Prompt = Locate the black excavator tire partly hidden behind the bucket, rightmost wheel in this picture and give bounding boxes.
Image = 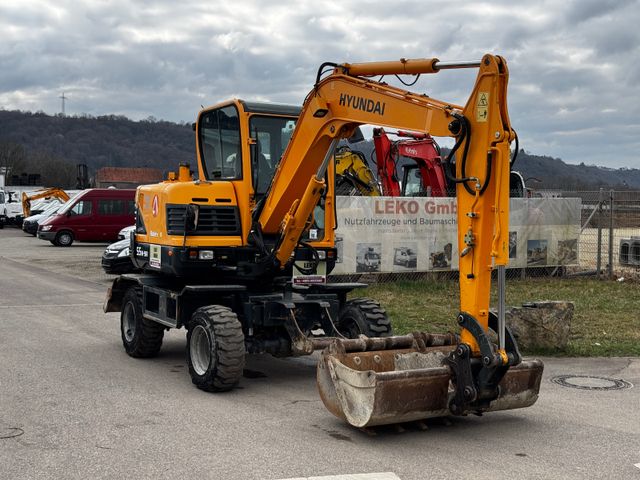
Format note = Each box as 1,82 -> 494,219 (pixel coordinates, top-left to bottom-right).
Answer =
337,298 -> 393,338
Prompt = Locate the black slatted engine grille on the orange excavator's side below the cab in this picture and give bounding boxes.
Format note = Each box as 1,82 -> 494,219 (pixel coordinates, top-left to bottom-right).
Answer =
167,204 -> 241,236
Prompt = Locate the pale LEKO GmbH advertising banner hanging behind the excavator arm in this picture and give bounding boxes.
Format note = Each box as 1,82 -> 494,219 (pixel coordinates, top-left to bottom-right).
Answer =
333,196 -> 581,274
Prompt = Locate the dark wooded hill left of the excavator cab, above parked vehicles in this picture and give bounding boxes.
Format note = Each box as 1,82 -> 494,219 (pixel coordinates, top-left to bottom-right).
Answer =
0,110 -> 195,188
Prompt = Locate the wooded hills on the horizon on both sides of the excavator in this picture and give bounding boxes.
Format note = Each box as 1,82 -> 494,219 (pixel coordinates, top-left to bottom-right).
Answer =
0,110 -> 640,190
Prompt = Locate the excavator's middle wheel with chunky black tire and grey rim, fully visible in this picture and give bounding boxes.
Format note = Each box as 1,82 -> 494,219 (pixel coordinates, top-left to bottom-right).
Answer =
187,305 -> 245,392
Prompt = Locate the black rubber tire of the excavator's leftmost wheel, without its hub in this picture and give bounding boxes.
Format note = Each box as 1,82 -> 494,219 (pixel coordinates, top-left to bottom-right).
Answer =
120,286 -> 165,358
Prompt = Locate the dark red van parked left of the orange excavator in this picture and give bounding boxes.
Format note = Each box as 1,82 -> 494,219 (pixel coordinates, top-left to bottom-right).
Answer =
38,188 -> 136,247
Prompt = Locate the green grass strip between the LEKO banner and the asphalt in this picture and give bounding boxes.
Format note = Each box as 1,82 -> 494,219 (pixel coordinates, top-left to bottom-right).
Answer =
353,278 -> 640,356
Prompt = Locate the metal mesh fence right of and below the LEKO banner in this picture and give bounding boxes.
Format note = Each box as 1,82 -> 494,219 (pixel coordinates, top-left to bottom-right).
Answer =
333,189 -> 640,283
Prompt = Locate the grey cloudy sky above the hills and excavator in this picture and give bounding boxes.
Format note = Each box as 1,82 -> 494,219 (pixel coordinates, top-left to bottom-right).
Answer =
0,0 -> 640,168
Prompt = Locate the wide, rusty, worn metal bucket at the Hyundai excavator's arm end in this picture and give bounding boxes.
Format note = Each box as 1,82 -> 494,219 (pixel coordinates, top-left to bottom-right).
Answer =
317,333 -> 543,428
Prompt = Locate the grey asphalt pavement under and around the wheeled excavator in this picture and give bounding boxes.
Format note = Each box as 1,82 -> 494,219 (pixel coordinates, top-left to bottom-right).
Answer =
0,228 -> 640,480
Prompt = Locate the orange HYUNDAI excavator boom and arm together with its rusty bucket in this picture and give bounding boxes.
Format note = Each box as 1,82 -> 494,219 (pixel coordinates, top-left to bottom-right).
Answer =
259,55 -> 543,426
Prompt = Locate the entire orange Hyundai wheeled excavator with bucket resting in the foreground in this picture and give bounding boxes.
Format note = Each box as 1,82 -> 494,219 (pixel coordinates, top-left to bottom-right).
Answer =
105,55 -> 543,427
